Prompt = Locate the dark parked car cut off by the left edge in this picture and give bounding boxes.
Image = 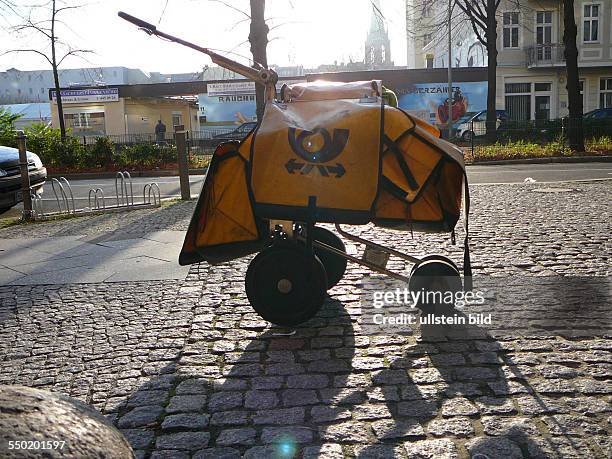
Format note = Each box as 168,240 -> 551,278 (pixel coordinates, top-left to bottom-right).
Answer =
0,146 -> 47,214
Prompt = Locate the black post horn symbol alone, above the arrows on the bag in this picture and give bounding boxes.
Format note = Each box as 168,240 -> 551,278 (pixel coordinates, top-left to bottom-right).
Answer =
289,128 -> 349,164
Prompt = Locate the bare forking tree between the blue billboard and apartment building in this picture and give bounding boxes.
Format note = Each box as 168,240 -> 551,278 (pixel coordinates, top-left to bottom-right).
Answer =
456,0 -> 501,141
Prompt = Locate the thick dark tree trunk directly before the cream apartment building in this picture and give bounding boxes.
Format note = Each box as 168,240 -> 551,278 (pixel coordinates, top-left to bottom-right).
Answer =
563,0 -> 584,151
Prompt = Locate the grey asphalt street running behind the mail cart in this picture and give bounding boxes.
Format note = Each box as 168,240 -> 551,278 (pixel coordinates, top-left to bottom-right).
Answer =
3,162 -> 612,217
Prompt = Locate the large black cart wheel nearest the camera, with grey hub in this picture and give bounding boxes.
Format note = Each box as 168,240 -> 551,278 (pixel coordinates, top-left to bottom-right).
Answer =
245,245 -> 327,326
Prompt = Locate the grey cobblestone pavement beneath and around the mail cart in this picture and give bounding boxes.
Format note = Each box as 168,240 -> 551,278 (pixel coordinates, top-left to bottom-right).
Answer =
0,182 -> 612,459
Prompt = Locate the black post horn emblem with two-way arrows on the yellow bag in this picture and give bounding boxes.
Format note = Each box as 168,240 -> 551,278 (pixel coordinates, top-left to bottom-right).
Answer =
285,128 -> 349,178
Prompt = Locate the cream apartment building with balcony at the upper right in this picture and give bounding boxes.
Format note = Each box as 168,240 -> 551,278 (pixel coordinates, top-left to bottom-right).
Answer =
497,0 -> 612,120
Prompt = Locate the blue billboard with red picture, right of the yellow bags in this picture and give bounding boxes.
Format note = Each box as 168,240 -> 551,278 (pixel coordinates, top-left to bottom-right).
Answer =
397,81 -> 487,126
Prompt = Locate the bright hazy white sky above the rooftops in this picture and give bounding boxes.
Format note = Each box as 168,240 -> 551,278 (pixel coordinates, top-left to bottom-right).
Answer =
0,0 -> 406,73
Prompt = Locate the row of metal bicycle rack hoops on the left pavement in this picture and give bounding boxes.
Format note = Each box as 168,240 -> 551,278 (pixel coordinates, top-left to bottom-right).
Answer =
31,171 -> 161,220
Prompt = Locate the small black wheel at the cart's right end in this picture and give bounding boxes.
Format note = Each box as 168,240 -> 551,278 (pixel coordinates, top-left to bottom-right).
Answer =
409,255 -> 463,313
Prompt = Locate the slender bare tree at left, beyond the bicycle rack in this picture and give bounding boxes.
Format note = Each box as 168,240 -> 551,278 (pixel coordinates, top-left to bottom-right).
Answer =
3,0 -> 91,140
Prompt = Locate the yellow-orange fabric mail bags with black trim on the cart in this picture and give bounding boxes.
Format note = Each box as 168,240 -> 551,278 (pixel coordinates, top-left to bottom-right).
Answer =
179,82 -> 465,264
